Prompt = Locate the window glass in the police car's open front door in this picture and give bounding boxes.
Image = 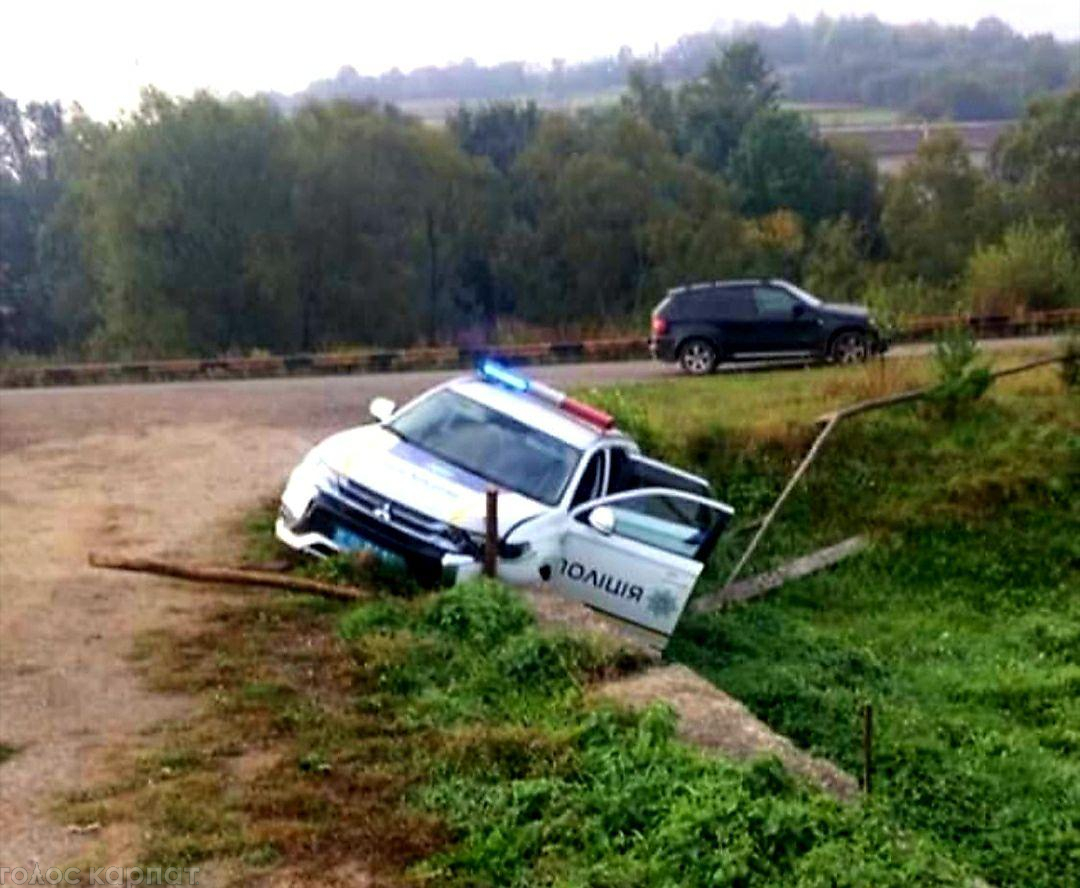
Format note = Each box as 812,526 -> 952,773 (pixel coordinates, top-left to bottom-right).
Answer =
596,493 -> 718,559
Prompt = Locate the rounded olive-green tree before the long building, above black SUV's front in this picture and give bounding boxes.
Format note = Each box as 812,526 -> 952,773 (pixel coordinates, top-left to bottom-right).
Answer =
881,132 -> 1003,282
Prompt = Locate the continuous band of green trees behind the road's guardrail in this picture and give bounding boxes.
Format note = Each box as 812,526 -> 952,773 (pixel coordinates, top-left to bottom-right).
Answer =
0,43 -> 1080,356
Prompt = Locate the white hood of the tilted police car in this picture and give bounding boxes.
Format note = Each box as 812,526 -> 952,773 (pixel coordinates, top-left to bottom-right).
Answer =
316,425 -> 551,535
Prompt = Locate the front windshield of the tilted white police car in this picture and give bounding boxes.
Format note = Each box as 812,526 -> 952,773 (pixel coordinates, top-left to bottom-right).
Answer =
387,389 -> 581,506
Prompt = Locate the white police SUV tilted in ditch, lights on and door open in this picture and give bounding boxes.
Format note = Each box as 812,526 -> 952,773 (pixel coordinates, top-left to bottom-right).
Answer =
275,361 -> 732,637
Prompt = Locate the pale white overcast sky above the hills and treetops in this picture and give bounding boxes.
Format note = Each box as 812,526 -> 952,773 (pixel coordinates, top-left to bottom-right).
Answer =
6,0 -> 1080,118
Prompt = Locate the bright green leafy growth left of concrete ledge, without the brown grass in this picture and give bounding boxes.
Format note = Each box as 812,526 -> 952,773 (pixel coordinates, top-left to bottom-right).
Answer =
341,584 -> 964,886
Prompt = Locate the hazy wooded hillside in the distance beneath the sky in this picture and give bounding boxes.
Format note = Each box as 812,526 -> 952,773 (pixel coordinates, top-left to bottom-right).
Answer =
270,16 -> 1080,120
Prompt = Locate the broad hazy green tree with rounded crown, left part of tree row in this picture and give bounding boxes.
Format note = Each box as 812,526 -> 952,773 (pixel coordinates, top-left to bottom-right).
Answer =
76,90 -> 287,354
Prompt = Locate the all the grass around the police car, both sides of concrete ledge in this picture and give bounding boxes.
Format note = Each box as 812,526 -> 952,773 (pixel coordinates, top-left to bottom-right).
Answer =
62,343 -> 1078,886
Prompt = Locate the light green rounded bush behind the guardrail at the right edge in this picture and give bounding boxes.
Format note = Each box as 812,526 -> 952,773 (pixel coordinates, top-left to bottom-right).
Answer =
967,219 -> 1080,315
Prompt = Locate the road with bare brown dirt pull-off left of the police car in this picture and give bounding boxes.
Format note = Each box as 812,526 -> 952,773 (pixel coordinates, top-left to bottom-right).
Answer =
0,332 -> 1062,869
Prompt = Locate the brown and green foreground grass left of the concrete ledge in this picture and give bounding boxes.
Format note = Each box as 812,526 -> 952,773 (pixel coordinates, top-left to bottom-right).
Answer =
78,561 -> 971,888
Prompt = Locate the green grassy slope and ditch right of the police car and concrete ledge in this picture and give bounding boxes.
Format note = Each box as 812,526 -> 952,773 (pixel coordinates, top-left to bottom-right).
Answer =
587,352 -> 1080,886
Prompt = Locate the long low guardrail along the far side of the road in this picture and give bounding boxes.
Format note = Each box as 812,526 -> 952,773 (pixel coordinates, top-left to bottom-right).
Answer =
0,309 -> 1080,388
